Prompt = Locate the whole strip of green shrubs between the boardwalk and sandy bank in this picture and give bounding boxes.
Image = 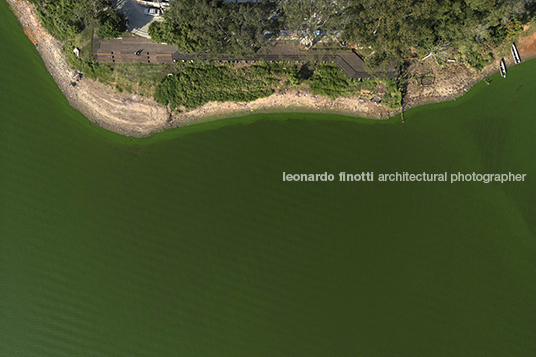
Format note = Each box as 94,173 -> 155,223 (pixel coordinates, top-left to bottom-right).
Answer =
154,61 -> 401,109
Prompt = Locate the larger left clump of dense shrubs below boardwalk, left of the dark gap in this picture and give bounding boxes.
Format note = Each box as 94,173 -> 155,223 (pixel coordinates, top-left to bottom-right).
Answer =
155,62 -> 297,109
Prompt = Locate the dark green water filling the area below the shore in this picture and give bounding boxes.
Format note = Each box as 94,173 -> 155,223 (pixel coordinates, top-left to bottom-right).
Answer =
0,0 -> 536,357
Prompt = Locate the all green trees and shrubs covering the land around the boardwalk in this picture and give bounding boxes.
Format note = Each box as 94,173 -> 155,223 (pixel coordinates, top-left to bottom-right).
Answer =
25,0 -> 536,108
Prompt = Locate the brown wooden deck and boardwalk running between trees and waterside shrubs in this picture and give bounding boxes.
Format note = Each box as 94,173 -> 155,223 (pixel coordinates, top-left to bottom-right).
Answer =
93,37 -> 394,78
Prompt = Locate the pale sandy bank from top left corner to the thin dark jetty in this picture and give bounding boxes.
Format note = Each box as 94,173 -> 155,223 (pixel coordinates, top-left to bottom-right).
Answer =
7,0 -> 396,137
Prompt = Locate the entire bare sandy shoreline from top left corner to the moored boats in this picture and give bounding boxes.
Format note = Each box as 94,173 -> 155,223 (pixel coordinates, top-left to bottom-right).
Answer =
7,0 -> 536,138
